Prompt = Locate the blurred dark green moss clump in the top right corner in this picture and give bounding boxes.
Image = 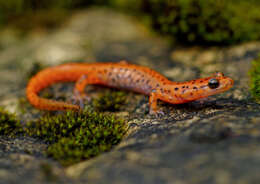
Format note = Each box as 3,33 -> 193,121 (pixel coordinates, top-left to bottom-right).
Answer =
138,0 -> 260,44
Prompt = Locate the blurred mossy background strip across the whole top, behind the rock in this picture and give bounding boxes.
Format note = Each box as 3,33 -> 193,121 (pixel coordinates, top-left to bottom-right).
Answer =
0,0 -> 260,45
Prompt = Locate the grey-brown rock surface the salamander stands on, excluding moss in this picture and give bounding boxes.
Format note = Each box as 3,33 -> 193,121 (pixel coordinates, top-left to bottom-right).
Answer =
0,9 -> 260,184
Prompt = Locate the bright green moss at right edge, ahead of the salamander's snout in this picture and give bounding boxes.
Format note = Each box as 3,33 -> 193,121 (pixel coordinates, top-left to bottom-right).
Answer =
249,56 -> 260,103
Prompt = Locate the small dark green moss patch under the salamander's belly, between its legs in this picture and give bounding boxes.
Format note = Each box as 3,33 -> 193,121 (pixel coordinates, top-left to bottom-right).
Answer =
92,91 -> 127,112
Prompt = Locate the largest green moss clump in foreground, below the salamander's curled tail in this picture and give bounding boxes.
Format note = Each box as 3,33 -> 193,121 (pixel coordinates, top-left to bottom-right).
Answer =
25,111 -> 126,166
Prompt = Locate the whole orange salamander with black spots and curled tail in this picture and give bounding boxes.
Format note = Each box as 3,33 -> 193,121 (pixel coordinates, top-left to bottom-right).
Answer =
26,61 -> 234,114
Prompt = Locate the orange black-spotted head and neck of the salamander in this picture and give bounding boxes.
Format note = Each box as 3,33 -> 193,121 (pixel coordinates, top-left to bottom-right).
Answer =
162,72 -> 234,103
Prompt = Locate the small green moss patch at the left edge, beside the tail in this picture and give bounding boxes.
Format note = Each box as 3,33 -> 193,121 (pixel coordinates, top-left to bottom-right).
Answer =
0,107 -> 23,137
